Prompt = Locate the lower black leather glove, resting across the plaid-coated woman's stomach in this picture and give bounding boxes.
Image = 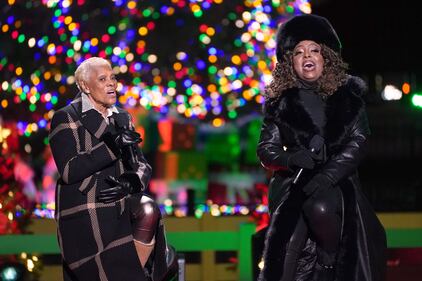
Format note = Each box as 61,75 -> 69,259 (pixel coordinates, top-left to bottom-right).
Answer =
97,172 -> 144,204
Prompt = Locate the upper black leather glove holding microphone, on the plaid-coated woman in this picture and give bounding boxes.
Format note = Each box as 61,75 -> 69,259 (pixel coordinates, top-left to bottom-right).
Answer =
102,129 -> 142,157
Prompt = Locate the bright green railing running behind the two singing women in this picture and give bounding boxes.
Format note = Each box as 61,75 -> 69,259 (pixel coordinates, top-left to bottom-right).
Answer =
0,215 -> 422,280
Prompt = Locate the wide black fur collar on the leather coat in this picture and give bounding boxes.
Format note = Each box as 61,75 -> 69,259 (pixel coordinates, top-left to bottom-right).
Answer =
264,76 -> 366,148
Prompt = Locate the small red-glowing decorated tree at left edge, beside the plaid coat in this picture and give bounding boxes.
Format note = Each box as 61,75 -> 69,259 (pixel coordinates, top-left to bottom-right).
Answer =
0,118 -> 40,281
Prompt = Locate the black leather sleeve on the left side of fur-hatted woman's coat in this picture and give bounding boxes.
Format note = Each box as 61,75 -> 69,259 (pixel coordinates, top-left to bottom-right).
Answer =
257,116 -> 291,170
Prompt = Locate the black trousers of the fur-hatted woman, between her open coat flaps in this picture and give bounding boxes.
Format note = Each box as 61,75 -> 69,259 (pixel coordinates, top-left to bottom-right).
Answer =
282,188 -> 342,281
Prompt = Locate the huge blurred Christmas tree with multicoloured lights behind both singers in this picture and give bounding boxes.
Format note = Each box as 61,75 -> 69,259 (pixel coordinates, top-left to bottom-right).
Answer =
0,0 -> 311,136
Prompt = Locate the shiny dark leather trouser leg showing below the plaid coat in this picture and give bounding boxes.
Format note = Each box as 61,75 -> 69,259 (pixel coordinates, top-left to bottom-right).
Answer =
129,195 -> 160,244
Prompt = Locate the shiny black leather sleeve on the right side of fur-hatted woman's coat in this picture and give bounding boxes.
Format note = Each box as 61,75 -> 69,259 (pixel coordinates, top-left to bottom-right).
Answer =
320,108 -> 370,185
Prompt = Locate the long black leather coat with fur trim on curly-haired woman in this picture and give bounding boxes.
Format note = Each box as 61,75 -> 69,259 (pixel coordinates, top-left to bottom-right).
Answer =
257,77 -> 386,281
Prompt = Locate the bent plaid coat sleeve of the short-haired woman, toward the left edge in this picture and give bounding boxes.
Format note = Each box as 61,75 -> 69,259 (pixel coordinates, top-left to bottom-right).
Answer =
49,110 -> 117,184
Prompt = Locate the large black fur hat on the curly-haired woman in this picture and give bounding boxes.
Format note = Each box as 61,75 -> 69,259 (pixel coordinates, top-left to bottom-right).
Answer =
276,14 -> 341,61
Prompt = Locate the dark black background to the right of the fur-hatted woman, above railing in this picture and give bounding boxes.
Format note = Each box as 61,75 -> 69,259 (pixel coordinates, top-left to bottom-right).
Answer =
310,0 -> 422,211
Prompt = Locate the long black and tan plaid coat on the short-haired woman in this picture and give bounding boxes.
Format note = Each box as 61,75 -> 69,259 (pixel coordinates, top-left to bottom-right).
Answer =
49,94 -> 167,281
